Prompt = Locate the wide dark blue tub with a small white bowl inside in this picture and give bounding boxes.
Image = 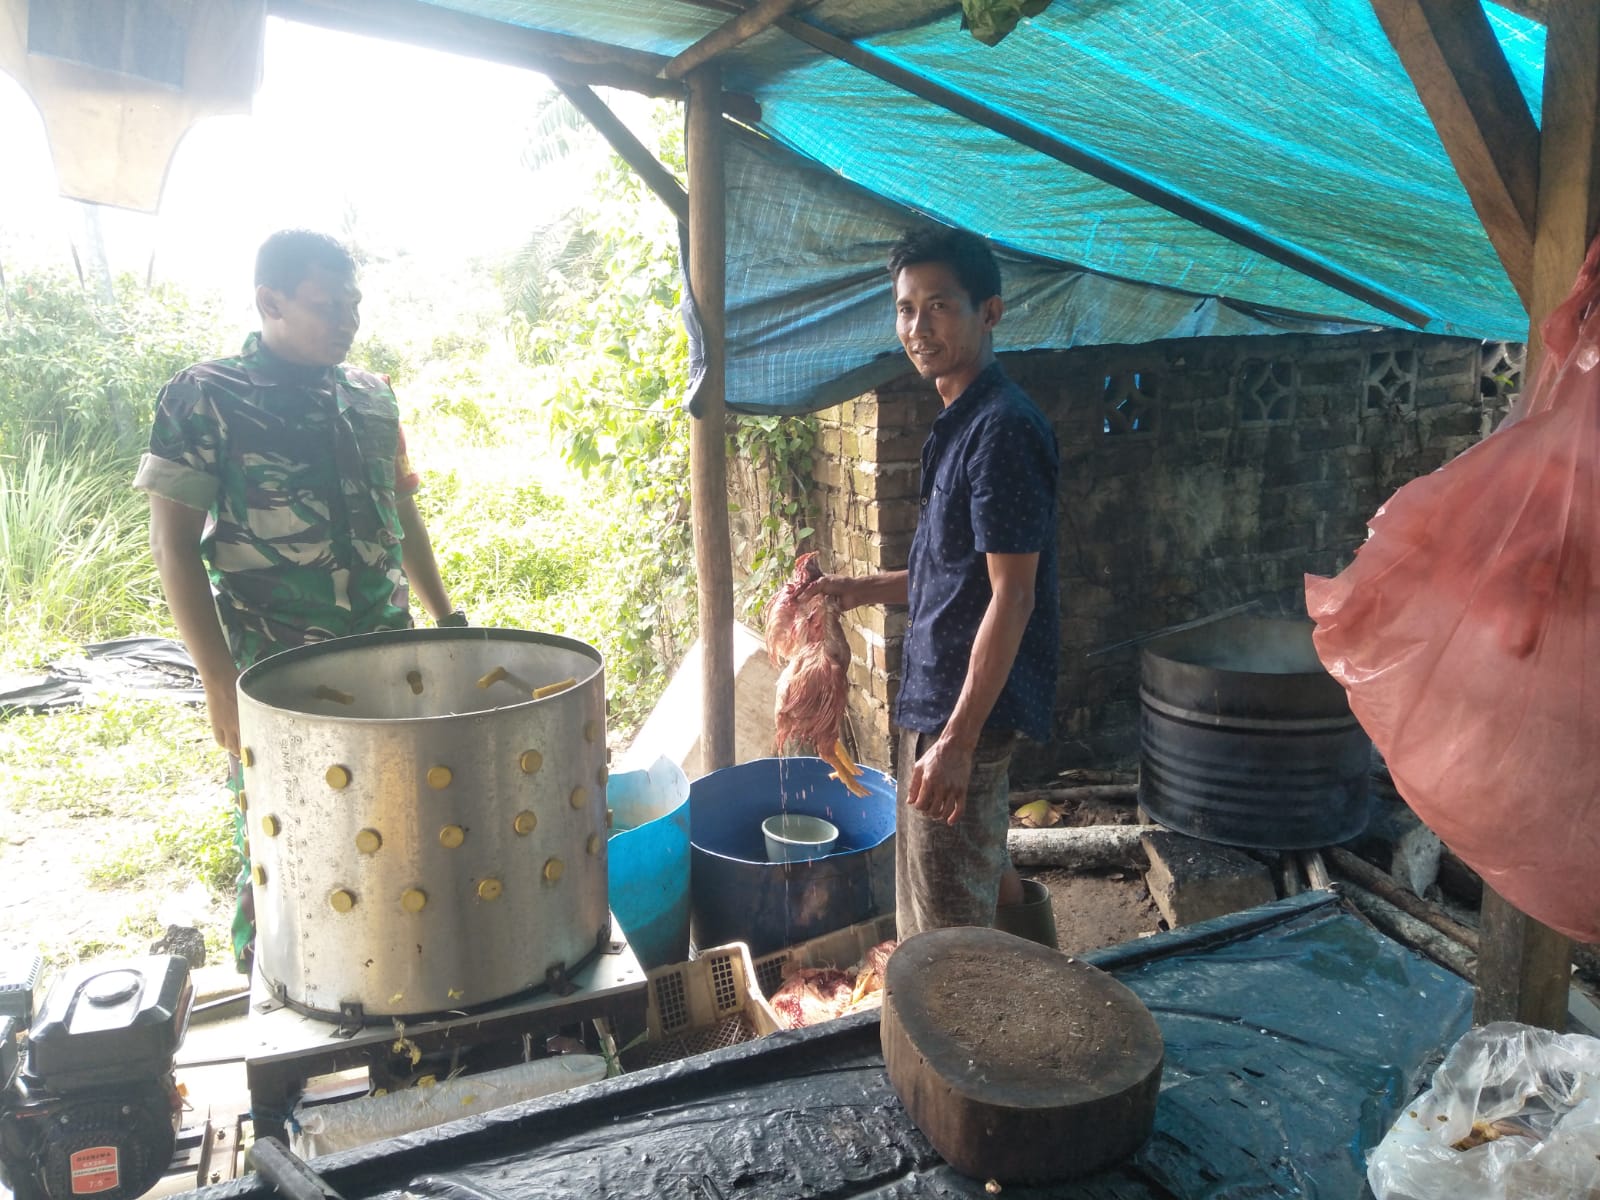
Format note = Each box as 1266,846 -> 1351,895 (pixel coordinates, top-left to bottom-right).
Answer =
690,758 -> 894,955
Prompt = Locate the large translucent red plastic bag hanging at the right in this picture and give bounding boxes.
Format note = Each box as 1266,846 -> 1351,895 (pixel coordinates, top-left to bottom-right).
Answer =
1306,240 -> 1600,941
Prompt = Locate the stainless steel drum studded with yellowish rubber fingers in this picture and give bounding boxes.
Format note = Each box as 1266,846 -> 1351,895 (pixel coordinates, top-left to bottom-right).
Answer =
240,629 -> 610,1018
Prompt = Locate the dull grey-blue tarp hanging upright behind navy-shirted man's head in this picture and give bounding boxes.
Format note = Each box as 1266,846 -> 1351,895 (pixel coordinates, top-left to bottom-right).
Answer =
707,131 -> 1371,413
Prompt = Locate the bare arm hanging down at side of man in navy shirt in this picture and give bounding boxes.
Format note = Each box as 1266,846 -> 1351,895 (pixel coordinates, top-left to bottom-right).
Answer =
907,554 -> 1038,826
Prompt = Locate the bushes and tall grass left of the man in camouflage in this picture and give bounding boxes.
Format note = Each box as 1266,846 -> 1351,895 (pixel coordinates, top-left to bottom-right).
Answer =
0,274 -> 218,678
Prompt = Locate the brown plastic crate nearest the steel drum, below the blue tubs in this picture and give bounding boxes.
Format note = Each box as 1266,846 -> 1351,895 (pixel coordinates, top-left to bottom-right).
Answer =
622,942 -> 778,1070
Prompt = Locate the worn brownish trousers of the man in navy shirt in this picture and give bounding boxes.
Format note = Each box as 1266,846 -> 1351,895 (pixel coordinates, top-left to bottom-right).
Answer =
894,730 -> 1016,939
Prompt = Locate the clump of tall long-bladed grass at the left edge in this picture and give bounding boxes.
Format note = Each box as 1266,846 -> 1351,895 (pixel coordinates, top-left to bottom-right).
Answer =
0,437 -> 166,662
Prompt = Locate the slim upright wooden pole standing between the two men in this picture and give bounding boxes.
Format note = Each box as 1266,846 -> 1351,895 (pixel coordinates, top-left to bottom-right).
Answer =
686,66 -> 734,771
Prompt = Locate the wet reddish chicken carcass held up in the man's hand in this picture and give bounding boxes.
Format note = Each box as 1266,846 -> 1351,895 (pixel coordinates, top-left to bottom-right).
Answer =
766,552 -> 867,795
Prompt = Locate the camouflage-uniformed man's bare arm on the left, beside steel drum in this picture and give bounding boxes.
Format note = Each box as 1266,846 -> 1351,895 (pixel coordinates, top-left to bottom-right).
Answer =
150,493 -> 238,755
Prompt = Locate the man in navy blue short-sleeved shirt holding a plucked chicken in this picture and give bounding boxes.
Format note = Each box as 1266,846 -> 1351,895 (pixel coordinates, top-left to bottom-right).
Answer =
813,227 -> 1059,938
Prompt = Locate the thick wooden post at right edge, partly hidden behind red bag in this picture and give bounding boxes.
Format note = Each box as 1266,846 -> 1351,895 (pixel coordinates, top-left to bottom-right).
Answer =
1472,0 -> 1600,1030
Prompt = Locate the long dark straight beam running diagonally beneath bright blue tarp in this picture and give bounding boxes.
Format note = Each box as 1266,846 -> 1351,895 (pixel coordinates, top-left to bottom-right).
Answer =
768,12 -> 1433,328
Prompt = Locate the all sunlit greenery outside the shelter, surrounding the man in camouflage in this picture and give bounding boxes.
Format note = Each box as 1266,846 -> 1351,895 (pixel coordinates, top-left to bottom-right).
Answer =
0,101 -> 816,962
